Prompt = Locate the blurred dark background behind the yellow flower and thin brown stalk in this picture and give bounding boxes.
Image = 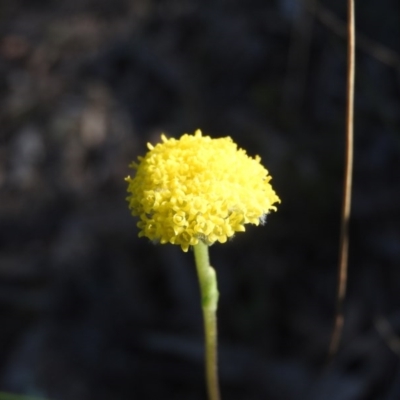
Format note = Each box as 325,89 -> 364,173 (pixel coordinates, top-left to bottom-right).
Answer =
0,0 -> 400,400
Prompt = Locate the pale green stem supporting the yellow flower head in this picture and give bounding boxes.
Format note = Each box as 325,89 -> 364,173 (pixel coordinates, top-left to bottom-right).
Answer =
194,241 -> 220,400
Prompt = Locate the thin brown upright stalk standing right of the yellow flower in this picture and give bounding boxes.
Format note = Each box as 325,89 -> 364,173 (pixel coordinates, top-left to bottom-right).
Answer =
328,0 -> 355,359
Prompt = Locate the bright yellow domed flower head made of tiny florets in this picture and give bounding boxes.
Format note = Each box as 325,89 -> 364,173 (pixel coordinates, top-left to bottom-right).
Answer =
126,130 -> 280,251
